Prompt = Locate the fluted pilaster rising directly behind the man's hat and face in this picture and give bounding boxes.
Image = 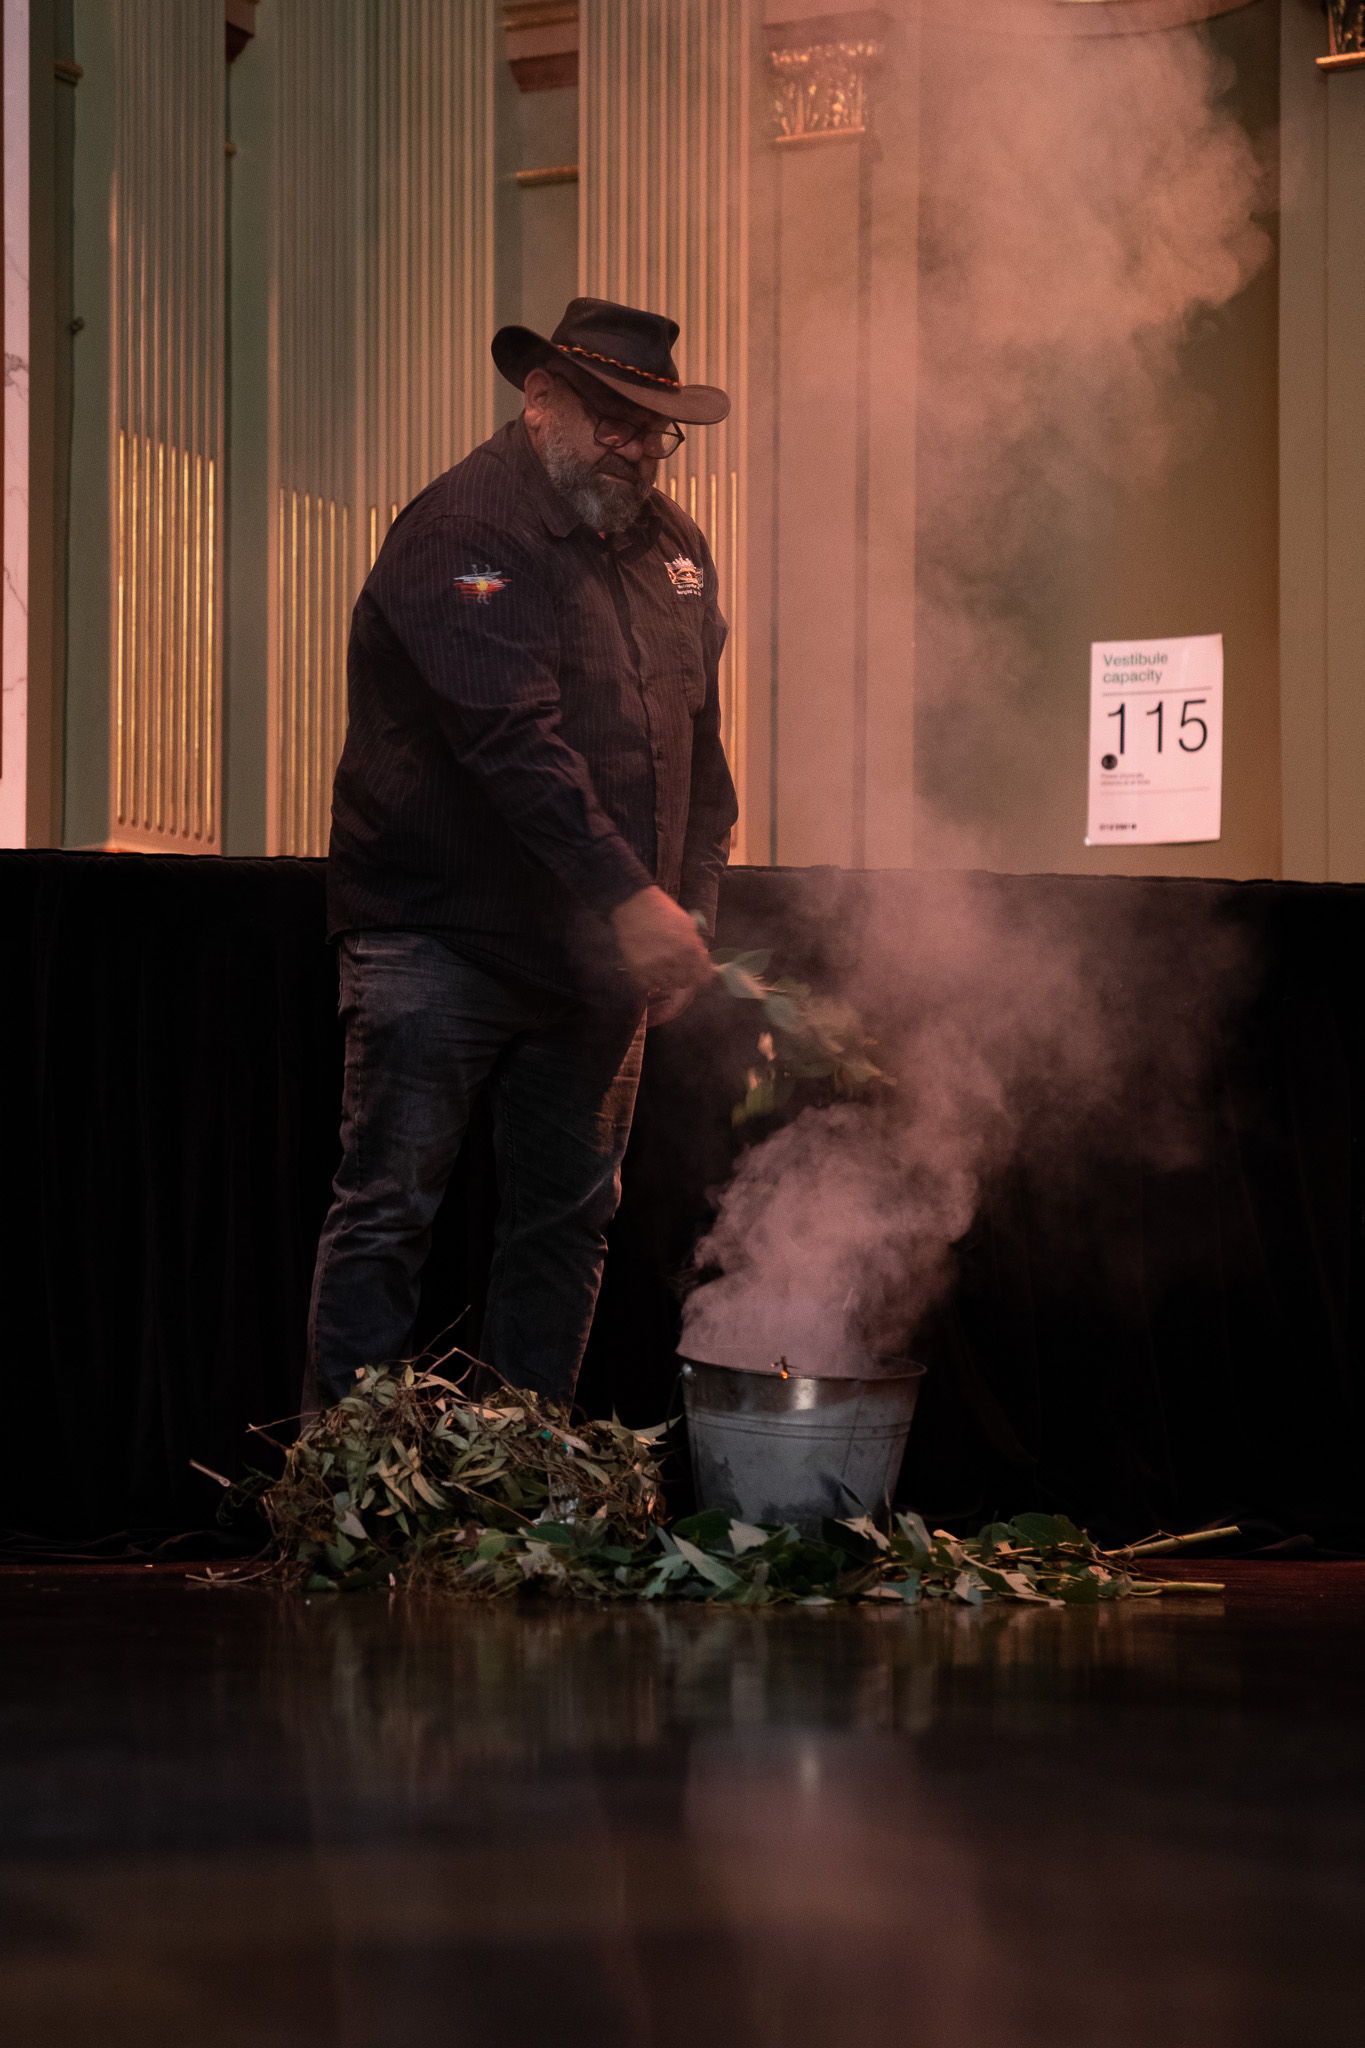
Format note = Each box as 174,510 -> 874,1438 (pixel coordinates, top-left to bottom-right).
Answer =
579,0 -> 753,860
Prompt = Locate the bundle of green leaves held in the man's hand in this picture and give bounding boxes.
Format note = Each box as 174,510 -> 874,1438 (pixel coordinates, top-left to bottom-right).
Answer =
712,950 -> 894,1124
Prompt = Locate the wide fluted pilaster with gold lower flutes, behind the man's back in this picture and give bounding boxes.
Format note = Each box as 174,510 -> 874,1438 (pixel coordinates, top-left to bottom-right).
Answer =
270,0 -> 501,854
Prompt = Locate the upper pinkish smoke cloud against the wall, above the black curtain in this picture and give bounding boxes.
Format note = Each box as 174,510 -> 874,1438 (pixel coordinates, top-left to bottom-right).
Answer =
917,8 -> 1271,862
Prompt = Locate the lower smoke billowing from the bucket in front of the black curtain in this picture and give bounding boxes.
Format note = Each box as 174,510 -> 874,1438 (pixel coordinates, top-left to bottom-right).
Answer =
684,874 -> 1250,1372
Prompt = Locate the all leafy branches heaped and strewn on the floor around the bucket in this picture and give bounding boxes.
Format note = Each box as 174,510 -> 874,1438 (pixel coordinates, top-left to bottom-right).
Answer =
211,1360 -> 1222,1606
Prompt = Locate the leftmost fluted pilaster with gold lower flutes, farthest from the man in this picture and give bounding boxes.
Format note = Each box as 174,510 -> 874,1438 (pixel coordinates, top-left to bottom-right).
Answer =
111,0 -> 225,852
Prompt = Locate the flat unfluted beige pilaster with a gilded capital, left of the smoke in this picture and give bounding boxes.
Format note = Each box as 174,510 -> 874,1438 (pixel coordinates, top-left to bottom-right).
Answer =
753,0 -> 919,868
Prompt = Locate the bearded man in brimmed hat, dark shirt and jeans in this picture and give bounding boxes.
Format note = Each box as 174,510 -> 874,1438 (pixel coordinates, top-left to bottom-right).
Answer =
305,299 -> 737,1403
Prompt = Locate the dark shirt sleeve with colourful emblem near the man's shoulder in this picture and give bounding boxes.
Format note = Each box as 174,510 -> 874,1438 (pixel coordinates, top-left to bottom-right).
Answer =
375,518 -> 653,915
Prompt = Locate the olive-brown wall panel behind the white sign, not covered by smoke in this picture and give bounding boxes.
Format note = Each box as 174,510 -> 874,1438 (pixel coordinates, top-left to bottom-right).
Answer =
919,0 -> 1281,877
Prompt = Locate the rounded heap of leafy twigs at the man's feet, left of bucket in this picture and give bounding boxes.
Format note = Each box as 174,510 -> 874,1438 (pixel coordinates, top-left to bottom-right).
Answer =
254,1360 -> 663,1591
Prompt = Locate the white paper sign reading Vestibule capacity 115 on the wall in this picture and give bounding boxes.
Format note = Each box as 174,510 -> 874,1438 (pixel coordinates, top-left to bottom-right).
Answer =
1085,633 -> 1224,846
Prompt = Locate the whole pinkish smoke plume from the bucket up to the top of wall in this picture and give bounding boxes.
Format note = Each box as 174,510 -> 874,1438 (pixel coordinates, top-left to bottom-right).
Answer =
684,8 -> 1269,1372
